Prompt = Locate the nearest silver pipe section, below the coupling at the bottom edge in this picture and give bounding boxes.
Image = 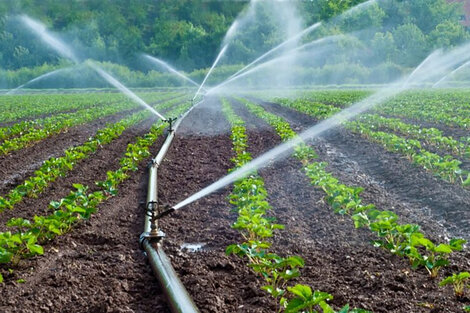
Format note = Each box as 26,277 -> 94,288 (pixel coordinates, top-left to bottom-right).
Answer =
143,240 -> 199,313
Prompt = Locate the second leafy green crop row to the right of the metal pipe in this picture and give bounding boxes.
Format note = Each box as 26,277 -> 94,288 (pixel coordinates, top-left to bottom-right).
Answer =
240,99 -> 466,298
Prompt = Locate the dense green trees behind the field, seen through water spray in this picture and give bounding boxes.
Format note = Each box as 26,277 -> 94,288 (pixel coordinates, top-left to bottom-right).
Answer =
0,0 -> 470,88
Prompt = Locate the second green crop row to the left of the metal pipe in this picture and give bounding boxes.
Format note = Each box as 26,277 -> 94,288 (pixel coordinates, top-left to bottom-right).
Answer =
0,96 -> 189,212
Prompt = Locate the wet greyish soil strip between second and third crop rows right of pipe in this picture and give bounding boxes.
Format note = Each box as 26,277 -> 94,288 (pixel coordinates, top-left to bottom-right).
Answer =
255,98 -> 470,239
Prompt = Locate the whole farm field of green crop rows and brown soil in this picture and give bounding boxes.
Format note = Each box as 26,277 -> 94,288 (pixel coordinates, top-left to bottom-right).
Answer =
0,89 -> 470,312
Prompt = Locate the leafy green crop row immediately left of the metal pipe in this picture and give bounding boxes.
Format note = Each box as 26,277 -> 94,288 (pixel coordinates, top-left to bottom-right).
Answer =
0,100 -> 189,280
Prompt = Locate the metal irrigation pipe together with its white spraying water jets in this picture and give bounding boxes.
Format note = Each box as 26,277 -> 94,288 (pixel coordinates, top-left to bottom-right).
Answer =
10,0 -> 470,313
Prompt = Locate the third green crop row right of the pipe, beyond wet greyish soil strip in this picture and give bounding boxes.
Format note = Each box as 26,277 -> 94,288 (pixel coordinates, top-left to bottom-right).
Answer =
277,99 -> 470,186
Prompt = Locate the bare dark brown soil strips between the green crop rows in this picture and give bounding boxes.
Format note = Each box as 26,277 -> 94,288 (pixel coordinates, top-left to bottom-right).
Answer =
0,95 -> 470,313
